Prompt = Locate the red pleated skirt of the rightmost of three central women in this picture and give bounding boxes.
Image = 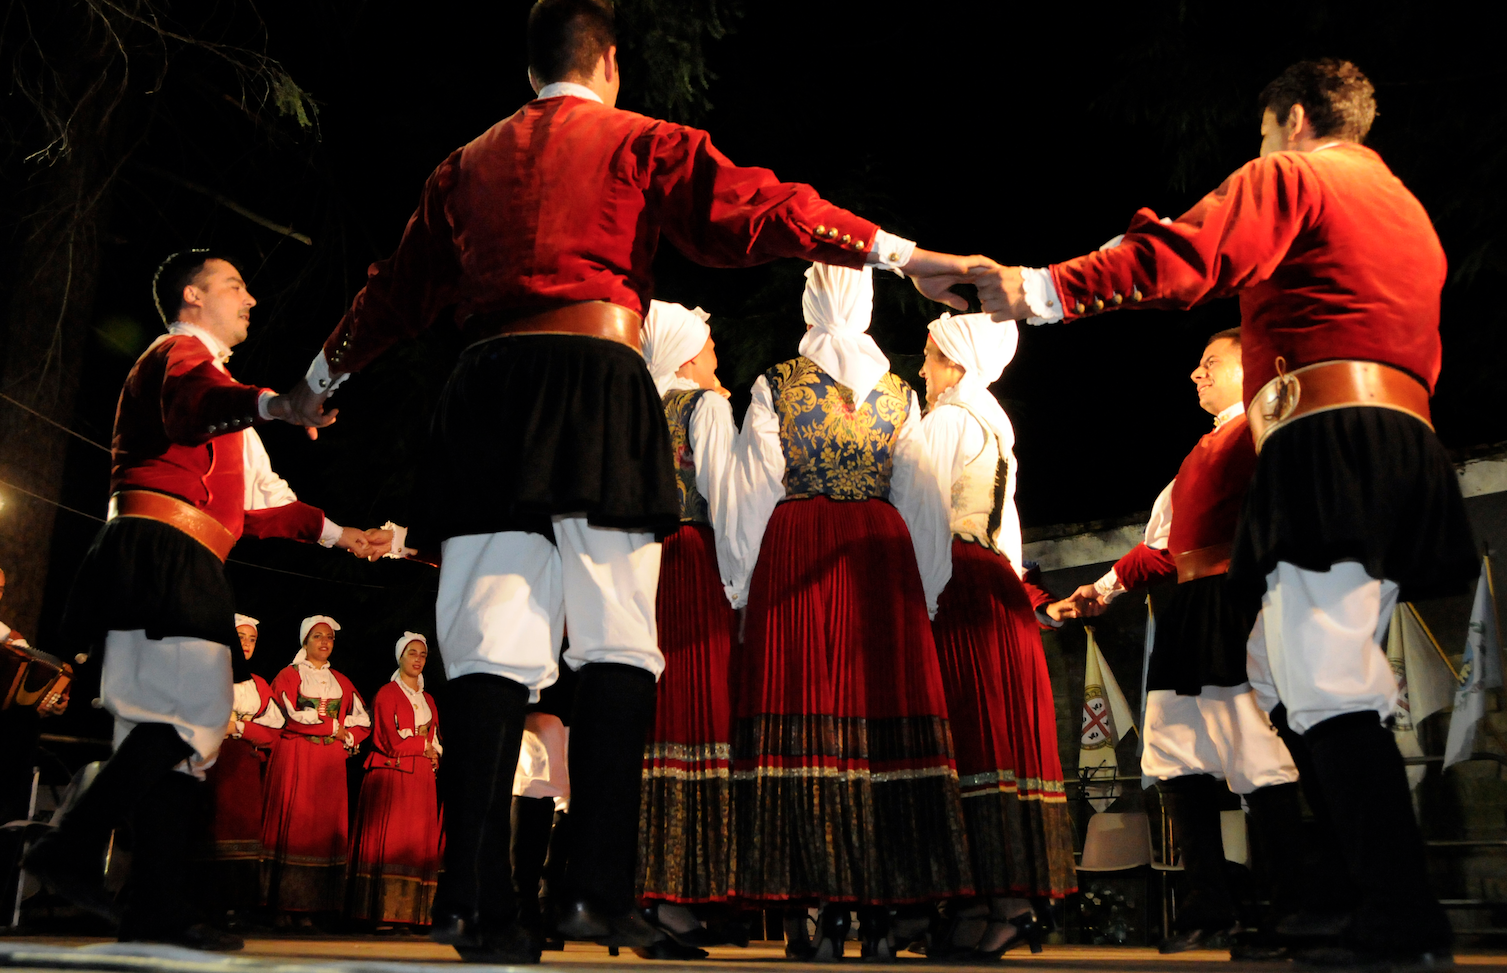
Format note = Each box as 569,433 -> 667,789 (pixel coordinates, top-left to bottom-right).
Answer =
933,538 -> 1078,898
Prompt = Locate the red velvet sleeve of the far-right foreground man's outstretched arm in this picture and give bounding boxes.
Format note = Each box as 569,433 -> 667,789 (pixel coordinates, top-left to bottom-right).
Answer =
1050,152 -> 1316,319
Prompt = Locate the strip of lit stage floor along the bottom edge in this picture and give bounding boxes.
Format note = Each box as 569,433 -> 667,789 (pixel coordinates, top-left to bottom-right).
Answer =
0,935 -> 1507,973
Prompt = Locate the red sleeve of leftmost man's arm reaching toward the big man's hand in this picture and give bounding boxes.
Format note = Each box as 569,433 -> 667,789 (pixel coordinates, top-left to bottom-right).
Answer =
161,336 -> 274,446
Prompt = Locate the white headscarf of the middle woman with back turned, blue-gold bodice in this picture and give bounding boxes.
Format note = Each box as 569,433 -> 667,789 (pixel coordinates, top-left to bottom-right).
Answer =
800,264 -> 889,405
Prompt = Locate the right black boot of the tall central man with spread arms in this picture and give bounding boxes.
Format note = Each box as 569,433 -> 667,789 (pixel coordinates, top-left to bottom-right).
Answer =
559,663 -> 659,946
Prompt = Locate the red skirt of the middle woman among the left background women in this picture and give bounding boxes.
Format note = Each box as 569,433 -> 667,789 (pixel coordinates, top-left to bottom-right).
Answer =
262,735 -> 350,913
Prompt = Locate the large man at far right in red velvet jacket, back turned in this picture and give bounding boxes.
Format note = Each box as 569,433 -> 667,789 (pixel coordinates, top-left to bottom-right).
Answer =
971,60 -> 1477,967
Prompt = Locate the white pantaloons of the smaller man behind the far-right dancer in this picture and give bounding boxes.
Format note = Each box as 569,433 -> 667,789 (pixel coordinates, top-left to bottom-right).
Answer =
1141,682 -> 1298,794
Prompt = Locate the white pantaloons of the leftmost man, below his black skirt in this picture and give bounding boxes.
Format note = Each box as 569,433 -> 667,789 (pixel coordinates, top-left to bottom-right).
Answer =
99,628 -> 240,780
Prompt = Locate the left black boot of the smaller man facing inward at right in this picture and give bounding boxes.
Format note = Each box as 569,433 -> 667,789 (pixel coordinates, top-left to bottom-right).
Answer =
1156,774 -> 1236,953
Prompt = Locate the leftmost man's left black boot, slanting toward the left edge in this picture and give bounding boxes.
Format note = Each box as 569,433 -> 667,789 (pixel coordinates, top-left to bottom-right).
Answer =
26,723 -> 193,922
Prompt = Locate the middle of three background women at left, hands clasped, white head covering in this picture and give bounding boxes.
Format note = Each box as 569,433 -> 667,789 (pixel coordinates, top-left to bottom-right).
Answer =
262,615 -> 372,926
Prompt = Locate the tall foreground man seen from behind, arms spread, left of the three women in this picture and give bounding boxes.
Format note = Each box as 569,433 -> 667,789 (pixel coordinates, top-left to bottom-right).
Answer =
283,0 -> 988,962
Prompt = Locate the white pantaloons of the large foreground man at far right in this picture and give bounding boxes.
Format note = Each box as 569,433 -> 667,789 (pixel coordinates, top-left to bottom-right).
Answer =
1246,560 -> 1397,734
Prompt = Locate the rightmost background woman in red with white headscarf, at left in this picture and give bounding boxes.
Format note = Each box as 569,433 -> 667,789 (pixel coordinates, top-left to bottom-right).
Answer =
351,631 -> 443,926
